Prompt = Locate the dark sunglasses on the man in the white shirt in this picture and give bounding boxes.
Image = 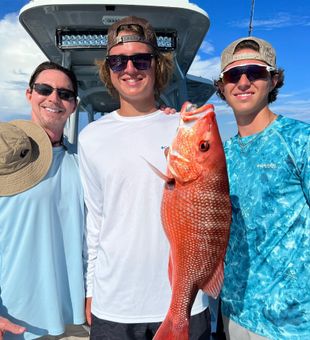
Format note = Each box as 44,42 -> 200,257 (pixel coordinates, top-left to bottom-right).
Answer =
106,53 -> 154,72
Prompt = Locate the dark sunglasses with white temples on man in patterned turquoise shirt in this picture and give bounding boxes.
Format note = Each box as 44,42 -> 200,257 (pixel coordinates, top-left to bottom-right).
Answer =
220,64 -> 276,84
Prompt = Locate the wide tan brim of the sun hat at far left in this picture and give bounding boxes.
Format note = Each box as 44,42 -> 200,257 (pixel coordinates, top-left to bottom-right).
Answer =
0,120 -> 53,196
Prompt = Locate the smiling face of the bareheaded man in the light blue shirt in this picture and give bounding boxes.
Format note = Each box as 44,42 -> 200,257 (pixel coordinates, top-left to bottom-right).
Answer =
26,69 -> 76,133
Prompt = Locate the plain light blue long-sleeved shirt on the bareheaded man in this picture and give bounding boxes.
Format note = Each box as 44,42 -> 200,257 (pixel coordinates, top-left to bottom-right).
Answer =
0,147 -> 84,339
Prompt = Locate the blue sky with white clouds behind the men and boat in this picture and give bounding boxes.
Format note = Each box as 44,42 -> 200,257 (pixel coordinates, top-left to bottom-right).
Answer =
0,0 -> 310,139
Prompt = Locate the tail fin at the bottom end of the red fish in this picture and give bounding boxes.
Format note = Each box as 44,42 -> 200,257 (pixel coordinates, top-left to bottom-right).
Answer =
153,312 -> 189,340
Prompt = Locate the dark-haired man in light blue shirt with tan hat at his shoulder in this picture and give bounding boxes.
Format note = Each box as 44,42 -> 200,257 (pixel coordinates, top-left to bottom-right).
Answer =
0,62 -> 88,339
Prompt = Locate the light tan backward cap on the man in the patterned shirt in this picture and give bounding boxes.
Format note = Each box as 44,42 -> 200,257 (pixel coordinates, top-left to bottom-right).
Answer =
221,37 -> 277,72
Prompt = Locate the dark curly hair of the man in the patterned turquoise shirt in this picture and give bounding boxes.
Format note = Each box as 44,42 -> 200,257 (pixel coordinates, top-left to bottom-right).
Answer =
214,40 -> 284,104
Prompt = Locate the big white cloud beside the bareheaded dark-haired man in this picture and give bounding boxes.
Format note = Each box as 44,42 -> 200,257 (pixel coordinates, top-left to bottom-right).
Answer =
0,14 -> 46,120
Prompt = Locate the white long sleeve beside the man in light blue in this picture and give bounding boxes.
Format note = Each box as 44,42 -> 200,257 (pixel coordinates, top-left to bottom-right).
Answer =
78,137 -> 103,297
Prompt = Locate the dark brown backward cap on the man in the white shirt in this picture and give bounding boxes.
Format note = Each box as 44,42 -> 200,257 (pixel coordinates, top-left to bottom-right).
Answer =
107,16 -> 158,53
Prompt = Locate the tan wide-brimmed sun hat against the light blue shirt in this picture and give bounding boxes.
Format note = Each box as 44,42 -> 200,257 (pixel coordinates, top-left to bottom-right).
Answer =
0,120 -> 53,196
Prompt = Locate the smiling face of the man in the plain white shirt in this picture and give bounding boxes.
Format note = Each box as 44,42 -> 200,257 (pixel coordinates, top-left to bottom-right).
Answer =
109,31 -> 155,108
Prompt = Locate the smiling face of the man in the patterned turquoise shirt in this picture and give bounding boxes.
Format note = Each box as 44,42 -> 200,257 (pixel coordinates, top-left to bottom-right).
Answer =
220,49 -> 277,117
